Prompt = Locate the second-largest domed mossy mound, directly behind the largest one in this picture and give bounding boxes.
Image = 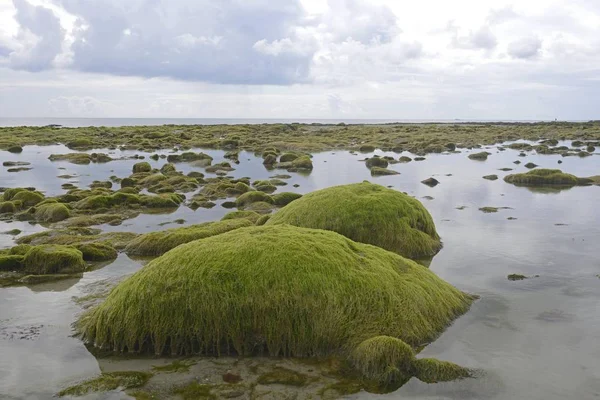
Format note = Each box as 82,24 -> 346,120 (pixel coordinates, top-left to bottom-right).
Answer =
267,181 -> 442,258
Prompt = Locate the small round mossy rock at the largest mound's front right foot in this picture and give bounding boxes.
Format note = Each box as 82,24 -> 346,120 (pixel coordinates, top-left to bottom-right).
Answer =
350,336 -> 415,387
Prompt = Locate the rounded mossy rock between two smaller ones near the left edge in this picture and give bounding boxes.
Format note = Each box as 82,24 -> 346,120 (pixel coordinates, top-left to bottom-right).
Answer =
23,244 -> 85,275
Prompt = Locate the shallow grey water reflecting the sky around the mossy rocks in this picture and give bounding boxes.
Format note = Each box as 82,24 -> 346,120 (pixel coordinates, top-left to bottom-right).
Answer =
0,141 -> 600,399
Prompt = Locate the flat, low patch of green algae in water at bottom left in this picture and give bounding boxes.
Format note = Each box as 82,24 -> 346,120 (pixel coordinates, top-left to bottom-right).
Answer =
58,371 -> 152,397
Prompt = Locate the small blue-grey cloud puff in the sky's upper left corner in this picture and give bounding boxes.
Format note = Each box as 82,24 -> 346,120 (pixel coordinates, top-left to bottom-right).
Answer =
8,0 -> 65,71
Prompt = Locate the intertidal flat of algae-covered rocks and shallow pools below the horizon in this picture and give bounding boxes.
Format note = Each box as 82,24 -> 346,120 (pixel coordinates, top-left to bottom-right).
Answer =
0,122 -> 600,399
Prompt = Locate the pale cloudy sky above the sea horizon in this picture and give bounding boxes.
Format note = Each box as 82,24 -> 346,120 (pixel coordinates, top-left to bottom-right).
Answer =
0,0 -> 600,120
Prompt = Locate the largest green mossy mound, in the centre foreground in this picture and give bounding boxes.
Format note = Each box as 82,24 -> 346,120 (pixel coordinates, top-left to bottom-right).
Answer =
78,225 -> 472,357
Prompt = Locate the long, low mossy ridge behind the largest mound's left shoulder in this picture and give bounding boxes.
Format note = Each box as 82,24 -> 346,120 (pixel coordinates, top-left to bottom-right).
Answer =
125,218 -> 254,256
